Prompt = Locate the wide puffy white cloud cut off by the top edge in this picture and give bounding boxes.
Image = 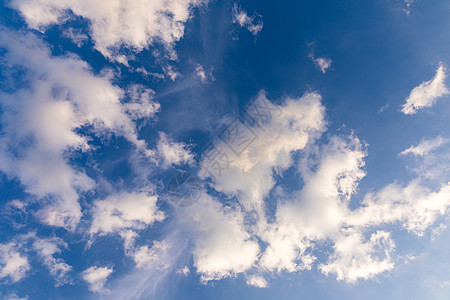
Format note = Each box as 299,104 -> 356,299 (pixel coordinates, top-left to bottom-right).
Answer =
10,0 -> 207,62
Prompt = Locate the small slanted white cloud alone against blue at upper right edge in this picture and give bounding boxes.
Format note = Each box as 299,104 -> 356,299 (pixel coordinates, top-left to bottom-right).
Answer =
402,63 -> 450,115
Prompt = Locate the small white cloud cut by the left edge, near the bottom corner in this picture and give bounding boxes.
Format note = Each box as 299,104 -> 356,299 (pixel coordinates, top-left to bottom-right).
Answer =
0,243 -> 30,282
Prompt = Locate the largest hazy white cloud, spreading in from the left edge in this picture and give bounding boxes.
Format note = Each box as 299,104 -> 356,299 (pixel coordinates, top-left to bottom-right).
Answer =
0,29 -> 158,229
